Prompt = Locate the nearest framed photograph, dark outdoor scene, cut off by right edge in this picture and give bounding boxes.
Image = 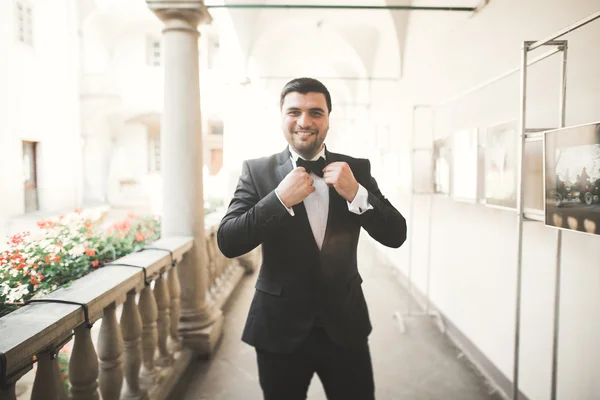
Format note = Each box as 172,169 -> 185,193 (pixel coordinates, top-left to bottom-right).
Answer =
544,122 -> 600,235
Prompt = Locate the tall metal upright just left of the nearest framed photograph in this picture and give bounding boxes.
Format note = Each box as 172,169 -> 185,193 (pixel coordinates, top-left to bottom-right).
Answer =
512,42 -> 533,400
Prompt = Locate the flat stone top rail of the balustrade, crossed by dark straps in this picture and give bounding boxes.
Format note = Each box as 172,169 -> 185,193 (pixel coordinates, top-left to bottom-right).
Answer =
0,237 -> 193,384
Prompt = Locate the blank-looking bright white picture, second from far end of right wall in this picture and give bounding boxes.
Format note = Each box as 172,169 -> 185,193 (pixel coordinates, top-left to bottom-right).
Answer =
450,128 -> 479,203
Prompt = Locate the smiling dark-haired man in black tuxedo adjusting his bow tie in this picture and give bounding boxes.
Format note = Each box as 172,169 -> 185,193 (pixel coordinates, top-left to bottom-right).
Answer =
218,78 -> 406,400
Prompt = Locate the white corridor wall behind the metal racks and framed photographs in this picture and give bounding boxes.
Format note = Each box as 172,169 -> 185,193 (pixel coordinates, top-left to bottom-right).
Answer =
374,0 -> 600,400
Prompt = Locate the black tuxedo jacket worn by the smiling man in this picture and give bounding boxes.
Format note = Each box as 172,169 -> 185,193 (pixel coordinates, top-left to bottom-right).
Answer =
217,148 -> 406,353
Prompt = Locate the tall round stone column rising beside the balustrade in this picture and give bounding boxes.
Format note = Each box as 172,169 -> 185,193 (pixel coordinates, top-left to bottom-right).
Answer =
146,0 -> 223,355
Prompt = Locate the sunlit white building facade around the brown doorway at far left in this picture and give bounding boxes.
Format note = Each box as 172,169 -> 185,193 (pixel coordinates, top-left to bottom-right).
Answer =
0,0 -> 80,231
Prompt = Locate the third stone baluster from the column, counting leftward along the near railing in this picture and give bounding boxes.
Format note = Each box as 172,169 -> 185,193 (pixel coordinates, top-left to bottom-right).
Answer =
139,285 -> 158,386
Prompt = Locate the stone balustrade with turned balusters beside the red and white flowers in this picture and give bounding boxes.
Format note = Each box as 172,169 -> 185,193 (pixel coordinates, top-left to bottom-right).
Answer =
0,219 -> 255,400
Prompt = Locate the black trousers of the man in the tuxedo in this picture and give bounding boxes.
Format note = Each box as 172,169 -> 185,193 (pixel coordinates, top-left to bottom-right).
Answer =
256,327 -> 375,400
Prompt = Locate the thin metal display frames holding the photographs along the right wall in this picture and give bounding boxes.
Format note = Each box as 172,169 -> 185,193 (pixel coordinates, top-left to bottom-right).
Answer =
407,11 -> 600,400
